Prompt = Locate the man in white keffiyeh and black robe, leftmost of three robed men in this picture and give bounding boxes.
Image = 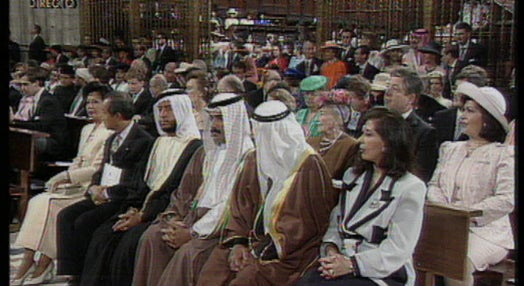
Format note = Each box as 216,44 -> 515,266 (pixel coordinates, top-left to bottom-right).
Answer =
81,94 -> 202,285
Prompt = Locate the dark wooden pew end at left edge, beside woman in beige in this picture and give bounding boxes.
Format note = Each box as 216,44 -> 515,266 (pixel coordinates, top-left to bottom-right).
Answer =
9,127 -> 50,222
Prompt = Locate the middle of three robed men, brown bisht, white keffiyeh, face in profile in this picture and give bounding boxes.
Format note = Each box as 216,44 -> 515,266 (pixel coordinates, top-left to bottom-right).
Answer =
133,93 -> 256,286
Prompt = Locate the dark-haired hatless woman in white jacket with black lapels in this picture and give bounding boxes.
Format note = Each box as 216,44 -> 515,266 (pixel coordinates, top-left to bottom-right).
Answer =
299,107 -> 426,286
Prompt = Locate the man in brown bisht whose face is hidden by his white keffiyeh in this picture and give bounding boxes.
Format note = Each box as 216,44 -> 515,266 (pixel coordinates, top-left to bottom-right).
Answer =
197,100 -> 338,286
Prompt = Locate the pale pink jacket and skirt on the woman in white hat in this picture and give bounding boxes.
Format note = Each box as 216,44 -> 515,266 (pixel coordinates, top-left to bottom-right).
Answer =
427,141 -> 515,270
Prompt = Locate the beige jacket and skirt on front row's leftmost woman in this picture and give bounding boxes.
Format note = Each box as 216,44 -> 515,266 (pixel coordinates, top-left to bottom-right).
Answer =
15,123 -> 112,259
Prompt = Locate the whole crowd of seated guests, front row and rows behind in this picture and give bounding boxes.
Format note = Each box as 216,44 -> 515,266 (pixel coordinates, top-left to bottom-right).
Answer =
9,20 -> 516,286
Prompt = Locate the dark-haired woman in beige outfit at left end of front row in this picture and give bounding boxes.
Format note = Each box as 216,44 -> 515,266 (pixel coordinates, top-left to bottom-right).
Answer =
11,84 -> 112,286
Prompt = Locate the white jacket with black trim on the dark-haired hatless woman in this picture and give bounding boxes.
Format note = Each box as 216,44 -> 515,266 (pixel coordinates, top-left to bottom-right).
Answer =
321,168 -> 426,285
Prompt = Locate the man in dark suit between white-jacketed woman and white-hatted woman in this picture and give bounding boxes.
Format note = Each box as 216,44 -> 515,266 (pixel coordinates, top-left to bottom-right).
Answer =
384,67 -> 438,182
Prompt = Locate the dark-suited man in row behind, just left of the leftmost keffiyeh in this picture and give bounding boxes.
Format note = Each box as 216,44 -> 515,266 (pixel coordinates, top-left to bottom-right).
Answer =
126,71 -> 153,117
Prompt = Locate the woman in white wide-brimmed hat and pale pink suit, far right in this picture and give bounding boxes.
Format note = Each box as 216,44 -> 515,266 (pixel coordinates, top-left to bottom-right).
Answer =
428,82 -> 515,285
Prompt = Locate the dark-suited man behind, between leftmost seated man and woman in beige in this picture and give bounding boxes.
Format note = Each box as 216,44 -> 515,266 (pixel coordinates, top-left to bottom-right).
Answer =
53,64 -> 80,113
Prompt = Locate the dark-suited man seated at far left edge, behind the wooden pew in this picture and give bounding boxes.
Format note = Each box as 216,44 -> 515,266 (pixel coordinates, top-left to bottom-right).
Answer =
11,67 -> 67,161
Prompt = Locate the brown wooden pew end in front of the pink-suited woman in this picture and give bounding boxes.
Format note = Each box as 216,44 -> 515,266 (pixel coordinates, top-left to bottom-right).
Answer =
413,202 -> 482,286
